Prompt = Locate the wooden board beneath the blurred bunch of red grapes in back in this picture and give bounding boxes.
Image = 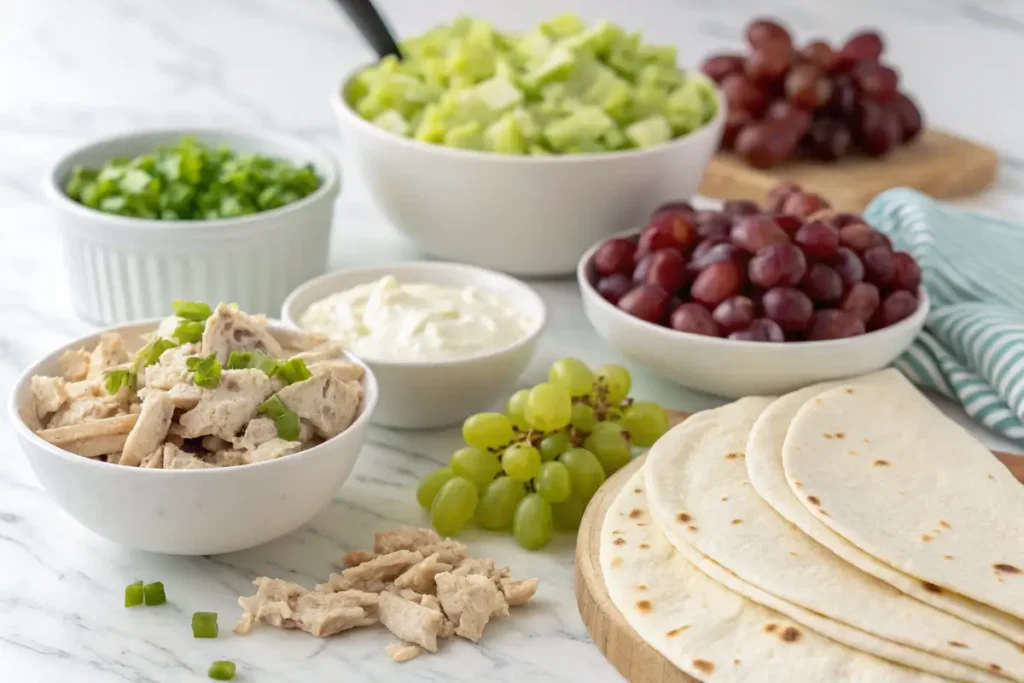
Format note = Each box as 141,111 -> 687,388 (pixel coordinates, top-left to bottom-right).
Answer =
698,129 -> 999,211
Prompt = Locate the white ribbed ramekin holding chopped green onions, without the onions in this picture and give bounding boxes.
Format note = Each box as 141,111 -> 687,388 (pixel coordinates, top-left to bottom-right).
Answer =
44,129 -> 341,325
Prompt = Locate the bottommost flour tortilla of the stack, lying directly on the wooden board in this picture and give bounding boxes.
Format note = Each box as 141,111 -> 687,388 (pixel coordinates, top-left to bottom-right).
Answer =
600,471 -> 946,683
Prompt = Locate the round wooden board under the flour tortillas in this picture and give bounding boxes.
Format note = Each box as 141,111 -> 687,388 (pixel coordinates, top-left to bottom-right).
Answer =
575,411 -> 1024,683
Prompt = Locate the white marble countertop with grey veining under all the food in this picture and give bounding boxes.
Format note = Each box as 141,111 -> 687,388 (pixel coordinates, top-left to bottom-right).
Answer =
0,0 -> 1024,683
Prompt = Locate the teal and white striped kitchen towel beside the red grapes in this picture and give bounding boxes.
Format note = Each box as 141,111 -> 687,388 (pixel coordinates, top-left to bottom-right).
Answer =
864,188 -> 1024,445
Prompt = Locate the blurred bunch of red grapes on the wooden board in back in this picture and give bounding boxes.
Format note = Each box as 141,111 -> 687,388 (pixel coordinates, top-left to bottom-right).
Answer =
701,19 -> 923,168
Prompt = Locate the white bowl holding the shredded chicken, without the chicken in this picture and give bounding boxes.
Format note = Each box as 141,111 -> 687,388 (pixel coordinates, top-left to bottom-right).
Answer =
8,321 -> 378,555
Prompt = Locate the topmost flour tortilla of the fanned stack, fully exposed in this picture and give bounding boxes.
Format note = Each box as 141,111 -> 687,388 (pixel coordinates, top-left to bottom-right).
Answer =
782,371 -> 1024,618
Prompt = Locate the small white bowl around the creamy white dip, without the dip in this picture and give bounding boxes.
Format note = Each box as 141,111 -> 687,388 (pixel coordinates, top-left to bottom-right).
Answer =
281,262 -> 547,429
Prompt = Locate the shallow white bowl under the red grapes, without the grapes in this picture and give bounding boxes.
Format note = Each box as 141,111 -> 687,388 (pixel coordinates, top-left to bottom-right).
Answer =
577,231 -> 929,398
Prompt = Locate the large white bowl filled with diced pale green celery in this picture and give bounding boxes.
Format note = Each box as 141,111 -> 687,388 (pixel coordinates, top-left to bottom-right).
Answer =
332,15 -> 726,275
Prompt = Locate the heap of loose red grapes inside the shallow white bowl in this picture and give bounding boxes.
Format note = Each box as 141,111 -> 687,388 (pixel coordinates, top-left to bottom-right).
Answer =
593,183 -> 921,342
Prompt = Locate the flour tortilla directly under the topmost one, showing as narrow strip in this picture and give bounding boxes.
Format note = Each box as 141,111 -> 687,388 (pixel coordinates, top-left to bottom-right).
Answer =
746,375 -> 1024,644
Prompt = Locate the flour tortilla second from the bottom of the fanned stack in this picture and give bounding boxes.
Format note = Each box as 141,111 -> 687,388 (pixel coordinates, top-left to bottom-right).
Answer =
646,398 -> 1024,683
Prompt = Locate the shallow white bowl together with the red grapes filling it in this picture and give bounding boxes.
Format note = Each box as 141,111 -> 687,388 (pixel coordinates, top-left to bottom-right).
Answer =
578,183 -> 929,397
